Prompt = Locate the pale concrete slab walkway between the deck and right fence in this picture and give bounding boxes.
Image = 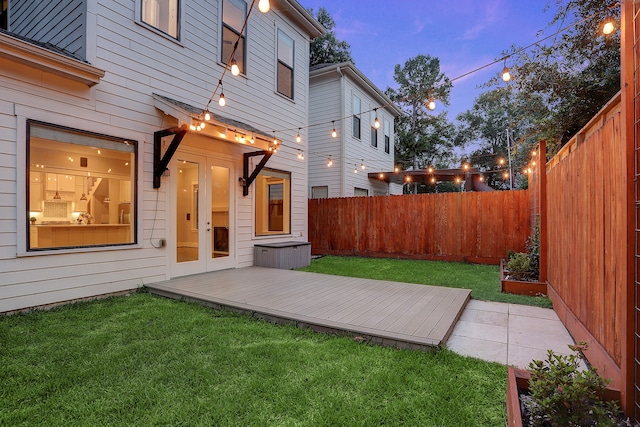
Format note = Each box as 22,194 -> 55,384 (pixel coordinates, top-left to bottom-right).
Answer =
447,300 -> 574,369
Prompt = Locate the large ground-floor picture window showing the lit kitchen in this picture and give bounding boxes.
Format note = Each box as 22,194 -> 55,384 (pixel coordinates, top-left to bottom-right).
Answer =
27,121 -> 137,251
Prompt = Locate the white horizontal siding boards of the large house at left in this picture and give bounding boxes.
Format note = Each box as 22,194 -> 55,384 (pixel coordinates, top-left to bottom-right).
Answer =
0,0 -> 318,312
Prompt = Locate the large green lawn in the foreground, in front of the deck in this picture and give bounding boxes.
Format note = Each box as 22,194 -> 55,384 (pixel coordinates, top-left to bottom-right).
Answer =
0,292 -> 506,426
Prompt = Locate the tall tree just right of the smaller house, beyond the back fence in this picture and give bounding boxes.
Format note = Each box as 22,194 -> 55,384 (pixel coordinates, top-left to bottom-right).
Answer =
386,55 -> 454,192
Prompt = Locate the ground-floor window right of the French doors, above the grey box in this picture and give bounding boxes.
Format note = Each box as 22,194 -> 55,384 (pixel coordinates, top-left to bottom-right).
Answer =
255,169 -> 291,236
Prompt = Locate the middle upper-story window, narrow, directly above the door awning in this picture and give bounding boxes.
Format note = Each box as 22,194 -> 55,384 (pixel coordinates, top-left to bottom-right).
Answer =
220,0 -> 247,74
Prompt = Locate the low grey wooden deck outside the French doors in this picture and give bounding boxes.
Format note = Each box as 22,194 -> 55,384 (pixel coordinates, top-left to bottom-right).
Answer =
146,267 -> 471,350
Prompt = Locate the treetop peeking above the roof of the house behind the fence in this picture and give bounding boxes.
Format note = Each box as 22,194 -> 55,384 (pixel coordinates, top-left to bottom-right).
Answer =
309,7 -> 354,66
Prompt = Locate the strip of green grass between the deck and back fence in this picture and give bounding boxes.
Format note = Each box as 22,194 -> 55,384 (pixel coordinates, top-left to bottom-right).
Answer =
301,256 -> 551,308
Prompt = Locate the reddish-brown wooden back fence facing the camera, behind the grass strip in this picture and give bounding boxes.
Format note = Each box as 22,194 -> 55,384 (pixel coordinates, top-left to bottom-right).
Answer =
309,190 -> 531,264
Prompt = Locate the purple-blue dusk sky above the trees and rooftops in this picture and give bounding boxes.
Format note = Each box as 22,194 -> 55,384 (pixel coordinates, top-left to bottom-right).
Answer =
299,0 -> 558,121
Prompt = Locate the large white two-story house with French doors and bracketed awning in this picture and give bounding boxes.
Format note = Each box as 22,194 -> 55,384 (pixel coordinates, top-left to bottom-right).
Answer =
0,0 -> 325,312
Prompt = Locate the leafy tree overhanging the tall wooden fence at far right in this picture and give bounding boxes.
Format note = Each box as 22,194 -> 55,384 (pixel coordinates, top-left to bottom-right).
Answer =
490,0 -> 620,152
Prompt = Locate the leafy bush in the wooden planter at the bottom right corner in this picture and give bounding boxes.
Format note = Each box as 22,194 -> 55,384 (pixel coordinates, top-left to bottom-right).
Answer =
527,341 -> 619,427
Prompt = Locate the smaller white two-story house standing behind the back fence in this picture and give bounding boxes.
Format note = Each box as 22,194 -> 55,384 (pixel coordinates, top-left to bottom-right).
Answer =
308,62 -> 402,198
